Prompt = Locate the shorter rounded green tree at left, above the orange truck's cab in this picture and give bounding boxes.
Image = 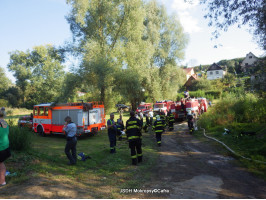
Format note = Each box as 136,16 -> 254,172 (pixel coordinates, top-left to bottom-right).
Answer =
8,45 -> 64,108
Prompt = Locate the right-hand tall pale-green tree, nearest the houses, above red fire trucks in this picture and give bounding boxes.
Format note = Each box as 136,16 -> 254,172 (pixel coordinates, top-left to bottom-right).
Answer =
143,1 -> 188,99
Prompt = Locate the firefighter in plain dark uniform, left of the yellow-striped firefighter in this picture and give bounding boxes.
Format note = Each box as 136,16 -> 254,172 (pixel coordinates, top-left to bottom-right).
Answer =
107,113 -> 117,154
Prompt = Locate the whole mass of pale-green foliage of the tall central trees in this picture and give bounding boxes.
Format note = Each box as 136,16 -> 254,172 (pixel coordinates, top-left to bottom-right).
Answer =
67,0 -> 187,110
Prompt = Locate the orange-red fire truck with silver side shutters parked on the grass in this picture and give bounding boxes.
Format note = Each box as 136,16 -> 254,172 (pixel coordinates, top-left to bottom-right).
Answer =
33,102 -> 105,136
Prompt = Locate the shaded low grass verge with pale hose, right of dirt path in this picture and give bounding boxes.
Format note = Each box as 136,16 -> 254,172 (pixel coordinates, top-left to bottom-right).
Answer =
193,123 -> 266,180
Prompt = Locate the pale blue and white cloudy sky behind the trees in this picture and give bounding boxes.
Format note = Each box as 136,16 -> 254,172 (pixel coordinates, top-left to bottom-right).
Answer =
0,0 -> 265,82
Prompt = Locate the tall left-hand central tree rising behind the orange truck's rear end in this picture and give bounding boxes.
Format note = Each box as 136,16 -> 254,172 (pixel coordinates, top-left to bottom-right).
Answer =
67,0 -> 145,107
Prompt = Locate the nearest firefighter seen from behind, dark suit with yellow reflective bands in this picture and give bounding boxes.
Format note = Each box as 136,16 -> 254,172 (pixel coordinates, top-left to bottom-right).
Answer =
126,111 -> 142,165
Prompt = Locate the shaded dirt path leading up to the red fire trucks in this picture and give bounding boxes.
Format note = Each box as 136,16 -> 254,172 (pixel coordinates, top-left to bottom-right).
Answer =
132,123 -> 266,199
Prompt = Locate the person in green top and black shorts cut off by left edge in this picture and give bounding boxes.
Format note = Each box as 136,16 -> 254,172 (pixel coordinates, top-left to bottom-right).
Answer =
0,108 -> 11,186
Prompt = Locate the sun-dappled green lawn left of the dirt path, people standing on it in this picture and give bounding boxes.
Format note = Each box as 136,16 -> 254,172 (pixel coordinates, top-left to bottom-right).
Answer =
6,113 -> 158,198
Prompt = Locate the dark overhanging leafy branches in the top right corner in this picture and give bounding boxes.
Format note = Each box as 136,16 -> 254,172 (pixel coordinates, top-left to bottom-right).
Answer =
200,0 -> 266,50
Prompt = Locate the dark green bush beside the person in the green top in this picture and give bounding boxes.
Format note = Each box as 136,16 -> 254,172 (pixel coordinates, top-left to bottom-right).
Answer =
8,120 -> 32,151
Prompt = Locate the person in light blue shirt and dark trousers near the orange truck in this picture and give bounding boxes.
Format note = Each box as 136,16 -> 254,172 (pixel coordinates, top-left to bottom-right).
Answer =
63,116 -> 77,165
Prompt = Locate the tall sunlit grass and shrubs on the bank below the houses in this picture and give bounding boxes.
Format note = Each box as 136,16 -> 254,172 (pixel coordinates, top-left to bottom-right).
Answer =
199,93 -> 266,129
